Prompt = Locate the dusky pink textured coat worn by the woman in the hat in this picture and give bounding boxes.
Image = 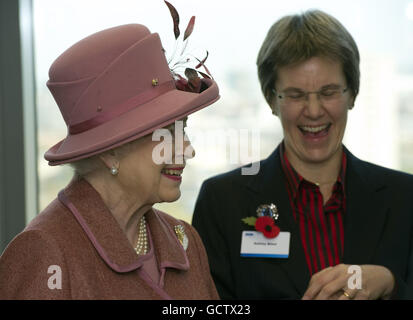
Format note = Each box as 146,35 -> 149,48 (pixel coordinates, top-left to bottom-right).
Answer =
0,180 -> 219,299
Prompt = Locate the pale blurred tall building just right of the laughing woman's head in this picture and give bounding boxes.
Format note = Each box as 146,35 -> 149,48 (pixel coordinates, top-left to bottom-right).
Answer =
344,50 -> 400,168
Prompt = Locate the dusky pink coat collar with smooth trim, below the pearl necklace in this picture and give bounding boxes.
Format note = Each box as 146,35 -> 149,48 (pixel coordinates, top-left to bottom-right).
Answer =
58,179 -> 189,273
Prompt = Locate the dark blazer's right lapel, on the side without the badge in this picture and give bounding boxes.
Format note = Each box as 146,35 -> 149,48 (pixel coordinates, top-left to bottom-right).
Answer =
344,149 -> 389,264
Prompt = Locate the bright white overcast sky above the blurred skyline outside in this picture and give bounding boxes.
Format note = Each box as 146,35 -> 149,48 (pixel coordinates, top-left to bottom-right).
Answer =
34,0 -> 413,81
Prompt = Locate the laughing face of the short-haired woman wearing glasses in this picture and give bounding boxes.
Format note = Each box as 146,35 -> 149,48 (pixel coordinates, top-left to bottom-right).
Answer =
272,57 -> 354,163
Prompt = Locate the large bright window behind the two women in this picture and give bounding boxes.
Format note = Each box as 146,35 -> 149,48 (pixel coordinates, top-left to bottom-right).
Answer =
34,0 -> 413,221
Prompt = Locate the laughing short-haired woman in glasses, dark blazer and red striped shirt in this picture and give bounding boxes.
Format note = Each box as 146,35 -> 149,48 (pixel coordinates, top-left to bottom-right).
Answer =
193,10 -> 413,299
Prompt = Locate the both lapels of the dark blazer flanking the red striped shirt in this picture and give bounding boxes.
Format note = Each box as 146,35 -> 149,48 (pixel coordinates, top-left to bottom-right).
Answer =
247,147 -> 389,295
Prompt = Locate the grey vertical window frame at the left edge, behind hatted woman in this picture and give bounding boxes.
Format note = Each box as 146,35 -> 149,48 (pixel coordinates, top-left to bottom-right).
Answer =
0,0 -> 38,253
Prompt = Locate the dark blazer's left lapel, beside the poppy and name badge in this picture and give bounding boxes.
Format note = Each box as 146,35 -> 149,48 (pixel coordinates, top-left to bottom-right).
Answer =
245,148 -> 310,297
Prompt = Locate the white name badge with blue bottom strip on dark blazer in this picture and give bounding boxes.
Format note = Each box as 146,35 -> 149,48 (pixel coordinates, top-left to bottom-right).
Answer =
241,231 -> 291,259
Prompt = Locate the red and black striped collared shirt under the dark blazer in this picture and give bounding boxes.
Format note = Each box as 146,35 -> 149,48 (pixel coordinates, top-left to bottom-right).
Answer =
280,143 -> 347,275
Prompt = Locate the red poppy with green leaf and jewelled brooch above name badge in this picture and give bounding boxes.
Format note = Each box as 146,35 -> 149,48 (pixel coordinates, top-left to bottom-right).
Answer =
241,203 -> 280,239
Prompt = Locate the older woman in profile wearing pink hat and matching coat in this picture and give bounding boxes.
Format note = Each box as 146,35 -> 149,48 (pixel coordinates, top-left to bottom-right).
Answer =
0,2 -> 219,299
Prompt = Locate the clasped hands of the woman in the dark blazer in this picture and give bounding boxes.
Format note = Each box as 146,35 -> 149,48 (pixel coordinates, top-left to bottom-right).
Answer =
303,264 -> 395,300
